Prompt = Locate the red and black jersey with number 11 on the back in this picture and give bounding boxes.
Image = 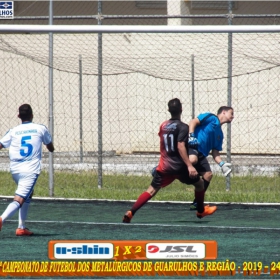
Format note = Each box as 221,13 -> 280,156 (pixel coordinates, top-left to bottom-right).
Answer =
156,119 -> 189,174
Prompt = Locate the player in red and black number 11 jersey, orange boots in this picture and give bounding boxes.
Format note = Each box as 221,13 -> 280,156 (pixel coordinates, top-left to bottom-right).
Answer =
123,98 -> 217,223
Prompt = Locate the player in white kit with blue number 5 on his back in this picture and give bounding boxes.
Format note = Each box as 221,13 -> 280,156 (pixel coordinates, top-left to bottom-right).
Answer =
0,104 -> 54,236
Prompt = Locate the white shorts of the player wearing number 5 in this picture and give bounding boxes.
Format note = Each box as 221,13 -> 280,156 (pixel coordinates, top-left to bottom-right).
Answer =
12,173 -> 39,200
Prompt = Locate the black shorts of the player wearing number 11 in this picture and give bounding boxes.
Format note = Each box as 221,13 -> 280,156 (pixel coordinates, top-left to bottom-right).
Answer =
151,167 -> 200,189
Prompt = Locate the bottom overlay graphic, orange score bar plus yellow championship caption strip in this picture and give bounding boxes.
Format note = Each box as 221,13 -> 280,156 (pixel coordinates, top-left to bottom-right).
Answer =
0,240 -> 274,278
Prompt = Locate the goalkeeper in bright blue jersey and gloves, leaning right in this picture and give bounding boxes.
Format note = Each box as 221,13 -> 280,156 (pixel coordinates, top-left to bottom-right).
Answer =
188,106 -> 234,210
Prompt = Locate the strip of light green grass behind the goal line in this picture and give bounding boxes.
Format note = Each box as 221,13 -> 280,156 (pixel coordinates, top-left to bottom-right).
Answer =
0,172 -> 280,203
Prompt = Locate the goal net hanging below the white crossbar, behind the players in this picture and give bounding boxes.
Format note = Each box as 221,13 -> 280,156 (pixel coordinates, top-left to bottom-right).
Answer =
0,26 -> 280,202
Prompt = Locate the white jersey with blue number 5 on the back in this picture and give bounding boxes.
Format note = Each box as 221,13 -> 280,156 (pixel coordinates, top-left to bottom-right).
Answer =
0,122 -> 52,174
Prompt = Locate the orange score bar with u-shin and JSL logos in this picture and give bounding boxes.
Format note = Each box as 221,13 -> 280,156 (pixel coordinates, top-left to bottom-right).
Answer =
48,240 -> 218,261
